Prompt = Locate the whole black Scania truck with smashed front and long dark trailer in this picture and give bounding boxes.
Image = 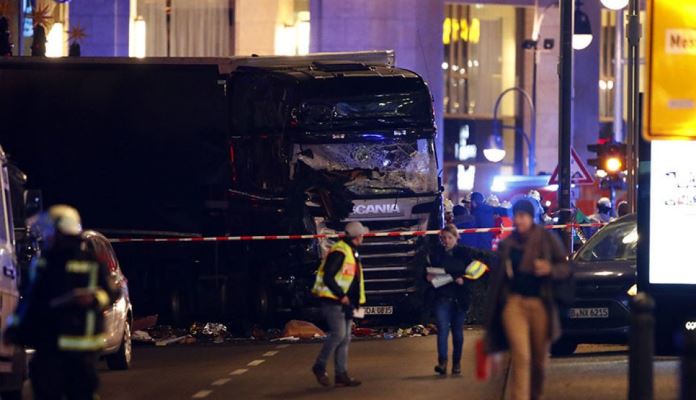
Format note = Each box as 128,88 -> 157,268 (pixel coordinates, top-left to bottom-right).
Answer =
0,52 -> 442,323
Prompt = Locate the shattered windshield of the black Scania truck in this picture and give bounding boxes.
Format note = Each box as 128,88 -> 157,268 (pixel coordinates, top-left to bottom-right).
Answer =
293,139 -> 437,195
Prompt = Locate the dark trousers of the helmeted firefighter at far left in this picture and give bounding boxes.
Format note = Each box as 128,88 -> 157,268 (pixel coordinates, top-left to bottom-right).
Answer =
29,351 -> 99,400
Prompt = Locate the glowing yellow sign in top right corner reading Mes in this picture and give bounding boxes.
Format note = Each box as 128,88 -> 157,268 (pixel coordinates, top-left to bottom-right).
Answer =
644,0 -> 696,140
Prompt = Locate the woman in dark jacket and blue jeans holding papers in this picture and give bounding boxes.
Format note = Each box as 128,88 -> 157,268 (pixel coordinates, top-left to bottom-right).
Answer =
426,224 -> 488,375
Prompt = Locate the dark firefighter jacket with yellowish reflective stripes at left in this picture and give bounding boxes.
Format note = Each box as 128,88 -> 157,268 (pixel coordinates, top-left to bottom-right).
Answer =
8,236 -> 119,352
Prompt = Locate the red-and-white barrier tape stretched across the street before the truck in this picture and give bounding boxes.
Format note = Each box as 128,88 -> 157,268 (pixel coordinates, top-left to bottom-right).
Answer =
109,223 -> 606,243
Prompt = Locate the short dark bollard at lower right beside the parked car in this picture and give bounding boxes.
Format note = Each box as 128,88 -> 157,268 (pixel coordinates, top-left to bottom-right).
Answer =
628,292 -> 655,400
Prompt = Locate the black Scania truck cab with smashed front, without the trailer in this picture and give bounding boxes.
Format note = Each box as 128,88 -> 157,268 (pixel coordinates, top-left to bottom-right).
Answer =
227,53 -> 442,322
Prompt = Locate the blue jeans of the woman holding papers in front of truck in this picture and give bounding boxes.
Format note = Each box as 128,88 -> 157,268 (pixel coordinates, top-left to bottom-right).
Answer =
435,298 -> 466,364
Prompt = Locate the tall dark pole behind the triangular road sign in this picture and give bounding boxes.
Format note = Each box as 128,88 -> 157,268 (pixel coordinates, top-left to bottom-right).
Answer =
558,0 -> 575,251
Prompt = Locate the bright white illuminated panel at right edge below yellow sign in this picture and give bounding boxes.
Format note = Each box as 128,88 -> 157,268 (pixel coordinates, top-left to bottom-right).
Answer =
649,140 -> 696,285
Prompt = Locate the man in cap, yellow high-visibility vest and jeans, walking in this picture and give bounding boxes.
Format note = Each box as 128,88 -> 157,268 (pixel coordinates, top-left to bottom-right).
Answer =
312,221 -> 369,387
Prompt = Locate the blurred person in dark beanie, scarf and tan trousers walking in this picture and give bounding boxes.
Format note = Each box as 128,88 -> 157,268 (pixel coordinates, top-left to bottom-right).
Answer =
486,199 -> 571,400
